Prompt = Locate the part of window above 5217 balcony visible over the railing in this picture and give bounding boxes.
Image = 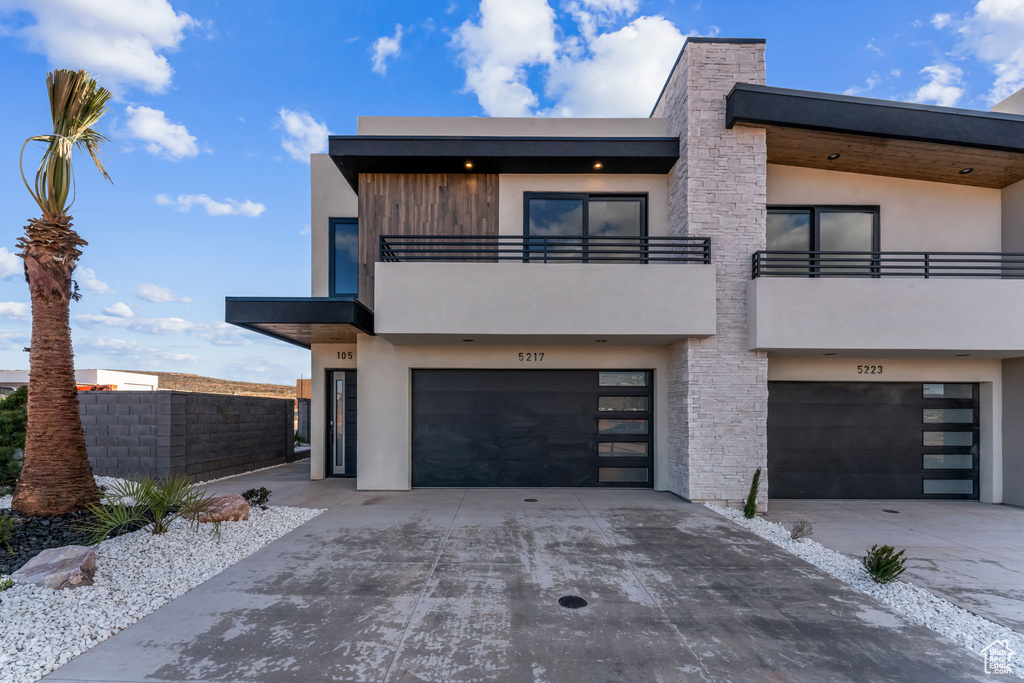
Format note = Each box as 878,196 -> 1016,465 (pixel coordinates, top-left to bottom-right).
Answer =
523,193 -> 647,238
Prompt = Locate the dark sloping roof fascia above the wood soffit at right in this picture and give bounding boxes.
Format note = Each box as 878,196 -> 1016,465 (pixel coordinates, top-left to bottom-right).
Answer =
725,83 -> 1024,153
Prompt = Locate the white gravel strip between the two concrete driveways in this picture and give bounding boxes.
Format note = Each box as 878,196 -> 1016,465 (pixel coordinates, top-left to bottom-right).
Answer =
705,503 -> 1024,678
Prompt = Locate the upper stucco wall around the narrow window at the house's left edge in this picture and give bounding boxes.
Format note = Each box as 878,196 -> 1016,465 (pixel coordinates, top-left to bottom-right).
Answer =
309,155 -> 359,296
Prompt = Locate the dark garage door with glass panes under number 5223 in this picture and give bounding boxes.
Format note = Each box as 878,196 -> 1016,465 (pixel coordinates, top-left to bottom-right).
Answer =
768,382 -> 979,500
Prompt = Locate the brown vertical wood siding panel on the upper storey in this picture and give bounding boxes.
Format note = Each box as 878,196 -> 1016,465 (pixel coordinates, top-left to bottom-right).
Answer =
359,173 -> 498,308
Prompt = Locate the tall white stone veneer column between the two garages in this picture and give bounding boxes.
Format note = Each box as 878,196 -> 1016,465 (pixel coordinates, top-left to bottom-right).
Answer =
651,38 -> 768,510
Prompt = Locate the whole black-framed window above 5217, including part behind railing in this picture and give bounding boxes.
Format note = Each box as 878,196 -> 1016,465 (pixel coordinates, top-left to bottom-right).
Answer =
523,193 -> 647,262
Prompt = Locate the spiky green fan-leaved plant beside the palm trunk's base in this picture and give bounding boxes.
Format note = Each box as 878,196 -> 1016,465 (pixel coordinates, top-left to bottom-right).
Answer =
79,474 -> 220,546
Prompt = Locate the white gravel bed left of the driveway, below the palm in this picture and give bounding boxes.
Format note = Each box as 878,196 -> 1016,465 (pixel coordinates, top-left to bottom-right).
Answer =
0,485 -> 324,683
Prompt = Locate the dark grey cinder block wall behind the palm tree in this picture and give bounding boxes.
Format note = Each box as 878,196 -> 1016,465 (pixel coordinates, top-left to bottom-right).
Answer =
79,391 -> 295,481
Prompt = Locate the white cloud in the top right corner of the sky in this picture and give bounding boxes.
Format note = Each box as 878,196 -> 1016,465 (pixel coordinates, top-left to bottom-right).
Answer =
950,0 -> 1024,103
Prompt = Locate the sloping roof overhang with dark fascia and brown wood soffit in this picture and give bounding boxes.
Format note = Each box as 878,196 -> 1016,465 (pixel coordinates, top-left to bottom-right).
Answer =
726,83 -> 1024,188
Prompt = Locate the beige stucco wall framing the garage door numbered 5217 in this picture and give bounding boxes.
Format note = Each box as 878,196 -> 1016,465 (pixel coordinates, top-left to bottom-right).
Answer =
350,335 -> 668,490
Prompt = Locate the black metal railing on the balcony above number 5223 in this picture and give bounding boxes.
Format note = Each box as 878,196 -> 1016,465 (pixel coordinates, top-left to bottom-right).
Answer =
753,251 -> 1024,278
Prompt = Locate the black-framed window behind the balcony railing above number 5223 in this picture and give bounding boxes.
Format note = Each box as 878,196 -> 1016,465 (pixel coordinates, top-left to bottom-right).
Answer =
766,206 -> 879,275
